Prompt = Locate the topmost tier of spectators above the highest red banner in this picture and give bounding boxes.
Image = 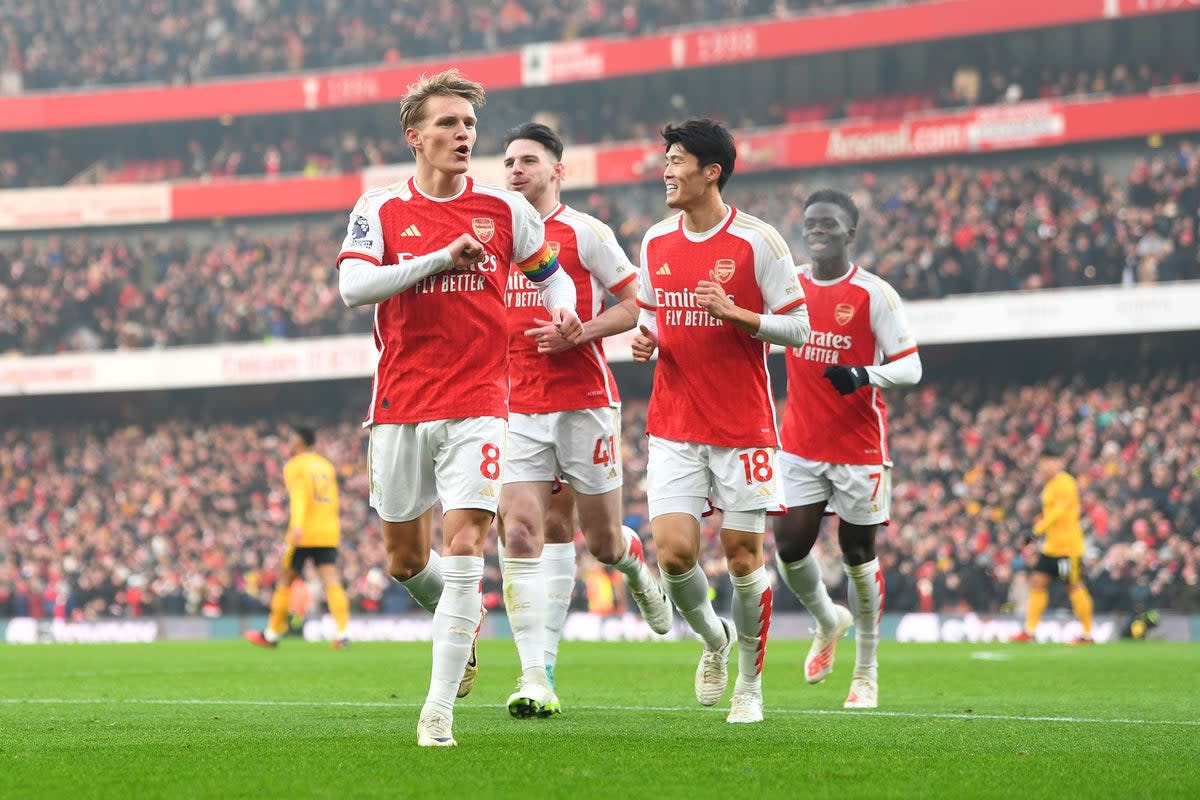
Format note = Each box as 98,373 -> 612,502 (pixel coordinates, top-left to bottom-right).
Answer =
0,0 -> 883,91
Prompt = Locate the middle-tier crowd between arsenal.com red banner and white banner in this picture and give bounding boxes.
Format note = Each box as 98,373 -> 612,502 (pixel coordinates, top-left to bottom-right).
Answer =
0,143 -> 1200,355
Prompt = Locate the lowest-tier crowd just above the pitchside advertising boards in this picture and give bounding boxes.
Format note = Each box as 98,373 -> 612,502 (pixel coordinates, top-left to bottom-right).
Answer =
0,368 -> 1200,619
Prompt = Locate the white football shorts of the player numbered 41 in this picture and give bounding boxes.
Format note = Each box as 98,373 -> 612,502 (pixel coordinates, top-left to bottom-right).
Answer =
504,407 -> 624,494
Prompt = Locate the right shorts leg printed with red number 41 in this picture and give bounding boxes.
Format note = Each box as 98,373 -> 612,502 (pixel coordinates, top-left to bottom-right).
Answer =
554,407 -> 624,494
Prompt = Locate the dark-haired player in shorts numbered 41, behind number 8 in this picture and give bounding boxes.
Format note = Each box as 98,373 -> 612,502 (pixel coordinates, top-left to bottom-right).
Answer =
500,122 -> 672,716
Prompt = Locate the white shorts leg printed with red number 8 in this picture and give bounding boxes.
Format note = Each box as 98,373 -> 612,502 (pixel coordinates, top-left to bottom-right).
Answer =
433,416 -> 506,515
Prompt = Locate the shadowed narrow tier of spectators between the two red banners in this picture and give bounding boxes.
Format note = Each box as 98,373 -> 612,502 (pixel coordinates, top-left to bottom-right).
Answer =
0,57 -> 1200,188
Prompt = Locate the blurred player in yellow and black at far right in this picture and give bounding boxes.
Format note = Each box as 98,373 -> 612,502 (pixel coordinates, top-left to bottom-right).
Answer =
1013,443 -> 1093,644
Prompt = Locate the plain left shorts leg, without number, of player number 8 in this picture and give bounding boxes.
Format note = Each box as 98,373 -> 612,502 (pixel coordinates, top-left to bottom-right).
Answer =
367,422 -> 438,522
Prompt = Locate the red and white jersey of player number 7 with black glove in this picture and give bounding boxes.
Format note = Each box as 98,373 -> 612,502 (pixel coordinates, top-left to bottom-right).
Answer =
782,265 -> 917,464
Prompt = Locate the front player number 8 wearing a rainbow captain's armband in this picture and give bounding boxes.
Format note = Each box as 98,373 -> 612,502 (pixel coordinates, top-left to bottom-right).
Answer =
337,70 -> 583,747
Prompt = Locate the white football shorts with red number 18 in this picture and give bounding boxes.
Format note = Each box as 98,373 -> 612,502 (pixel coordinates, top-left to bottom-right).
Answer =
646,437 -> 786,518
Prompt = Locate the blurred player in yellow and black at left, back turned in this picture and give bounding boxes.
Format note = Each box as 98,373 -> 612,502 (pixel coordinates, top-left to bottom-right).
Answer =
246,427 -> 350,650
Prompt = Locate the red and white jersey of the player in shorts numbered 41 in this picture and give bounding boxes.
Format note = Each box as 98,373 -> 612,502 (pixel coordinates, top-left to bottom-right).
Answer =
506,204 -> 637,414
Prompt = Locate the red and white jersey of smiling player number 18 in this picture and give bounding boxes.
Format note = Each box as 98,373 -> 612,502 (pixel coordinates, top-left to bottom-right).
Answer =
637,206 -> 804,447
